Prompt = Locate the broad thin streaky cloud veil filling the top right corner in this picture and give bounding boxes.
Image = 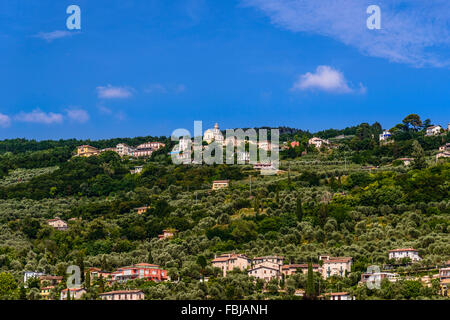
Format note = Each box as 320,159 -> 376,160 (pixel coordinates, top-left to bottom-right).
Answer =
241,0 -> 450,67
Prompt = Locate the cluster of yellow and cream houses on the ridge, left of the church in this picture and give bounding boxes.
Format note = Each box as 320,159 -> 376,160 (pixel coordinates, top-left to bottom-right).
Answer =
77,142 -> 165,158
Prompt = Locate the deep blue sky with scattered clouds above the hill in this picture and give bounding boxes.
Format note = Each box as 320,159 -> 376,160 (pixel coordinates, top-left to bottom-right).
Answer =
0,0 -> 450,140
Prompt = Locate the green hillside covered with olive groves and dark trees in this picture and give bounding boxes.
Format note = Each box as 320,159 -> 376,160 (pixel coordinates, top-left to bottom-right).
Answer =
0,114 -> 450,299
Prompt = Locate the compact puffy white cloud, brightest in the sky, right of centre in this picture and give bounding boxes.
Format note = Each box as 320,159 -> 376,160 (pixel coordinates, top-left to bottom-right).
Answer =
291,66 -> 366,93
